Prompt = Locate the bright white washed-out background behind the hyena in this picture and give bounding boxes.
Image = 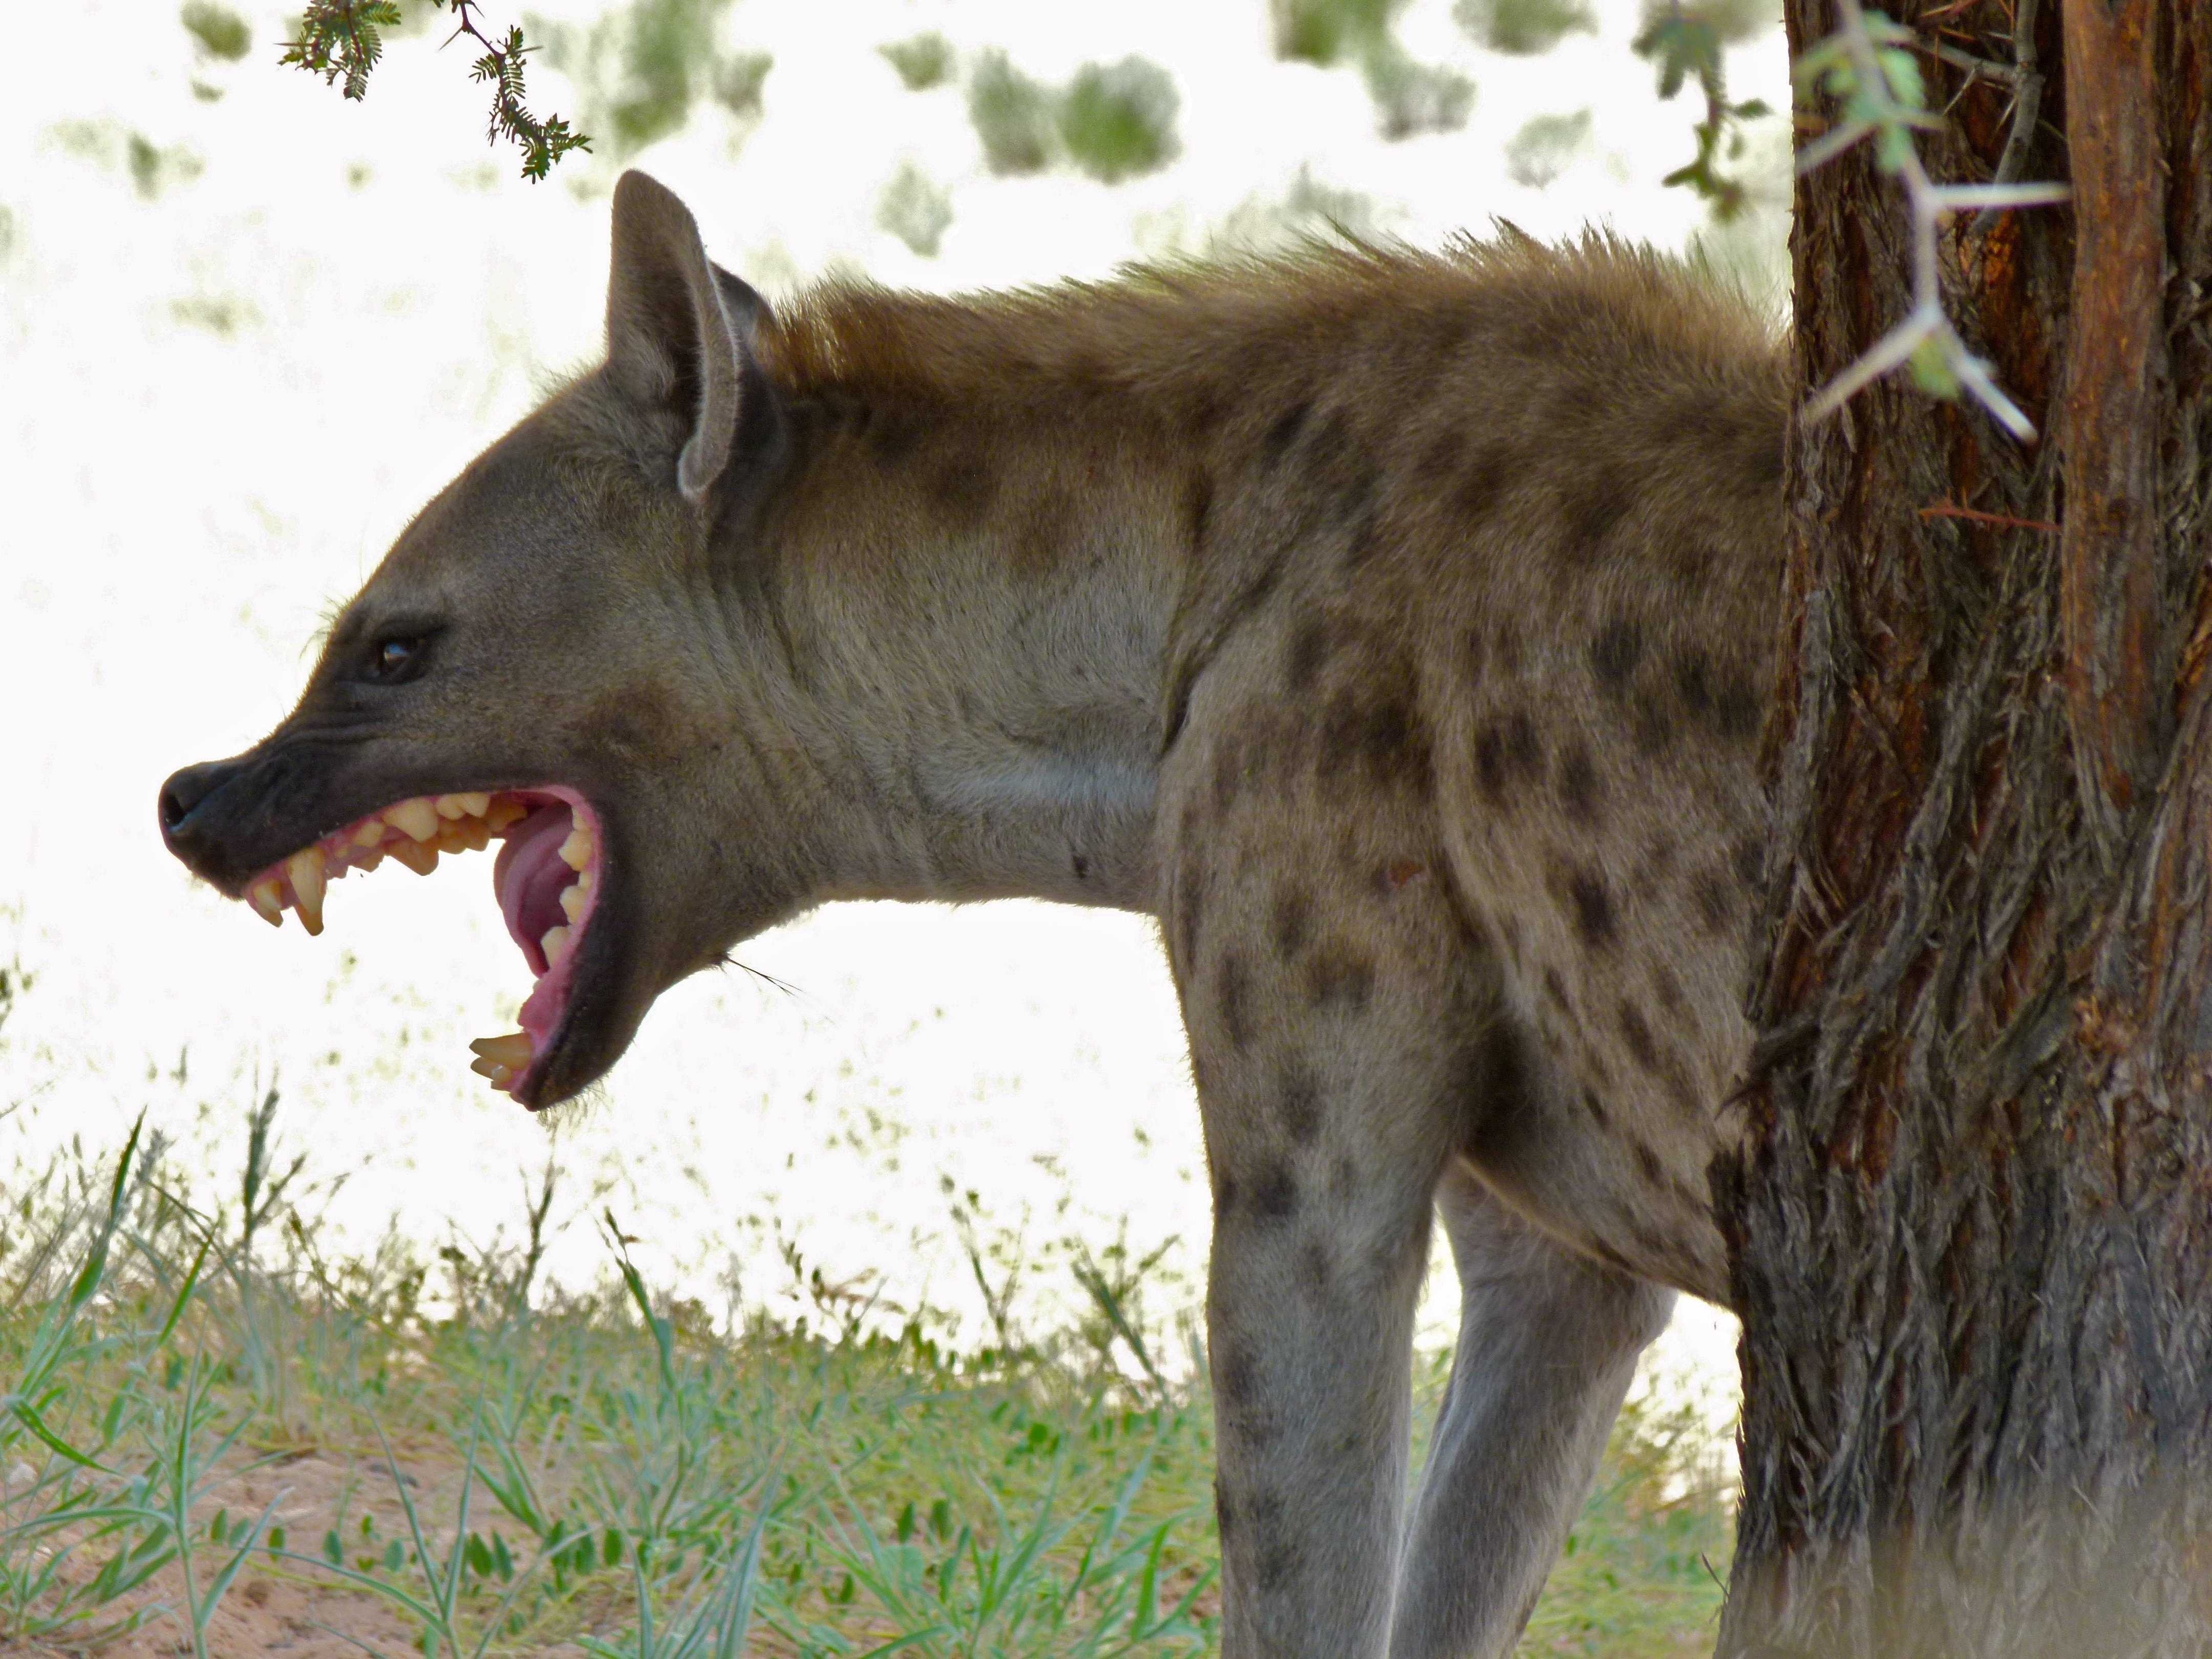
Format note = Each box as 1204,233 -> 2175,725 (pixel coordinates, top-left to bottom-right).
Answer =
0,0 -> 1788,1433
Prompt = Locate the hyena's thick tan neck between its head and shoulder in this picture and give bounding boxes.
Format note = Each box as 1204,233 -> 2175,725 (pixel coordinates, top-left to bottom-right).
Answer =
738,318 -> 1188,909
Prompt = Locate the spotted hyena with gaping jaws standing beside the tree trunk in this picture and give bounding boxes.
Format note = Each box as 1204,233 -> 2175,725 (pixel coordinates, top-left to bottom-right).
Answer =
159,173 -> 1785,1659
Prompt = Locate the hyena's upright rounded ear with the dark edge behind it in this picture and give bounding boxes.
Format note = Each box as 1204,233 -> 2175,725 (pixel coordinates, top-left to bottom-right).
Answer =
606,173 -> 765,502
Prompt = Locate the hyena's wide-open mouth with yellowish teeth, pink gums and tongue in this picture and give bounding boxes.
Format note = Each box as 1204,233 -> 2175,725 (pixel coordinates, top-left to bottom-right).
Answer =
246,785 -> 606,1099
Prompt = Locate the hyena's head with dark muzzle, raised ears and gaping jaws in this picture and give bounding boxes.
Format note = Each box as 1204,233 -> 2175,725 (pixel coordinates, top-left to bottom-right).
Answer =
159,173 -> 838,1108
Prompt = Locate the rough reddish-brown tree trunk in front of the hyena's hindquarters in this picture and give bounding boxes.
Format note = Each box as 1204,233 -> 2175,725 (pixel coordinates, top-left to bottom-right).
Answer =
1714,0 -> 2212,1659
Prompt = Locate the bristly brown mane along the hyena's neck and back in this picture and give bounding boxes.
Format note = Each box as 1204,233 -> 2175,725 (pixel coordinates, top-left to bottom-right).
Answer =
761,237 -> 1776,424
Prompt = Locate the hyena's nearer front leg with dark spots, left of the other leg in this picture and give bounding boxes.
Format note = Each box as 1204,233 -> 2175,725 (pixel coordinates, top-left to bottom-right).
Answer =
1166,708 -> 1486,1659
